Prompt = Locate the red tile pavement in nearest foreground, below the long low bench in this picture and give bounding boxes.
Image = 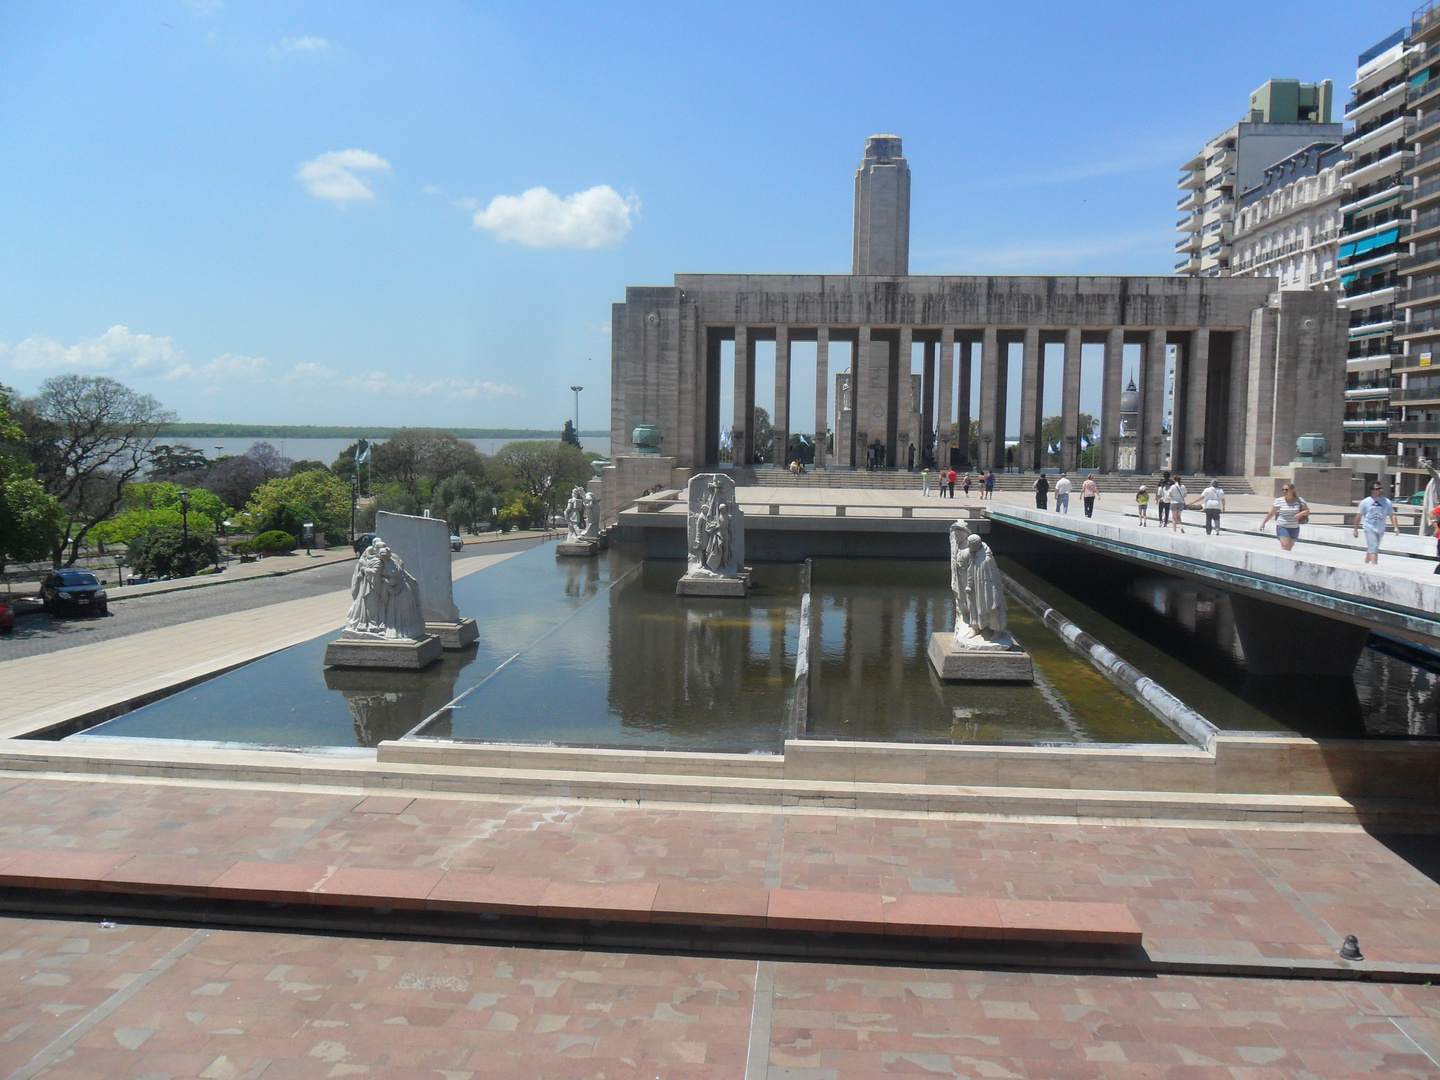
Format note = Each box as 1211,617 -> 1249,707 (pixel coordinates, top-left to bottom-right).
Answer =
0,917 -> 1440,1080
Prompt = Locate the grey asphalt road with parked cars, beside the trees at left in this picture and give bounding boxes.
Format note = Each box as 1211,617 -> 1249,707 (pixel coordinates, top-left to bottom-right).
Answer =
0,537 -> 544,661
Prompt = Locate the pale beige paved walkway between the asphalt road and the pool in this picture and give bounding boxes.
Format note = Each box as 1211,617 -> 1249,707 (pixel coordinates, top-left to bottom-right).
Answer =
0,552 -> 516,739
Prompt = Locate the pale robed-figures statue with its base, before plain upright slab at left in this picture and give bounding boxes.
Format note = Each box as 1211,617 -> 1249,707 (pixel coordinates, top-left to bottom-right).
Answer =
325,537 -> 441,668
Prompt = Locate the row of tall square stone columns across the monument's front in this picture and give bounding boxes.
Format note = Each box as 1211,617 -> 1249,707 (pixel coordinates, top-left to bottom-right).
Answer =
714,323 -> 1248,472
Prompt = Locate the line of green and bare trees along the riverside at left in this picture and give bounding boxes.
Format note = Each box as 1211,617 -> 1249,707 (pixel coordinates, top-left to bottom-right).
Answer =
0,374 -> 595,576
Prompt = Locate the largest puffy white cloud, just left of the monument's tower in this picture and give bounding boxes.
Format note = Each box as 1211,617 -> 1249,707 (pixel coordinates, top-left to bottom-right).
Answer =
475,184 -> 639,248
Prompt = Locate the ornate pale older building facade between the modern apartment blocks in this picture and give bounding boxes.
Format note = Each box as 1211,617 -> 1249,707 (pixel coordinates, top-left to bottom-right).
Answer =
1230,143 -> 1346,291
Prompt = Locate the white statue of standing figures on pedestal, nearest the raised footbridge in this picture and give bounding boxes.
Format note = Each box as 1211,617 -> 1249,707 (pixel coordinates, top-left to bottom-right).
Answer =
927,521 -> 1035,683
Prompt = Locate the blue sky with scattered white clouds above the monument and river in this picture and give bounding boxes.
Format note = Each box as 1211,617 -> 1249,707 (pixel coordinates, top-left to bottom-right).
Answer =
0,0 -> 1413,429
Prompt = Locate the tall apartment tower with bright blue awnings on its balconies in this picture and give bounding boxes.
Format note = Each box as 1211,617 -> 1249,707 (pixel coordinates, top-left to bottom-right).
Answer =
1338,29 -> 1413,460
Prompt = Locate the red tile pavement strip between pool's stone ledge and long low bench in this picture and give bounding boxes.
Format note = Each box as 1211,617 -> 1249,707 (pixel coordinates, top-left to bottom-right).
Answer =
0,779 -> 1440,963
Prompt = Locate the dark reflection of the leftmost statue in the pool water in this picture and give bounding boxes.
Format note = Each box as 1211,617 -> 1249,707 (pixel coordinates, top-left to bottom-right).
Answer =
325,645 -> 477,746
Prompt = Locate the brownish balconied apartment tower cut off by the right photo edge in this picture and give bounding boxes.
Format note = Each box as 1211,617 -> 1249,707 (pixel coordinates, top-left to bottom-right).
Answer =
1393,0 -> 1440,494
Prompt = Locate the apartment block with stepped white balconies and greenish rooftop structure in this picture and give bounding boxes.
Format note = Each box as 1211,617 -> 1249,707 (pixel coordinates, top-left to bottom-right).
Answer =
1175,79 -> 1344,278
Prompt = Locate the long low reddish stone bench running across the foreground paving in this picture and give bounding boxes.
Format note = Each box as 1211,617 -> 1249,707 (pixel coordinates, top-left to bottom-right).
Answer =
0,848 -> 1140,946
